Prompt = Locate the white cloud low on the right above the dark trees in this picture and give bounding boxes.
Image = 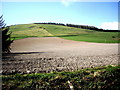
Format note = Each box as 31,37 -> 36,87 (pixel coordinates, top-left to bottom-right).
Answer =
99,22 -> 118,30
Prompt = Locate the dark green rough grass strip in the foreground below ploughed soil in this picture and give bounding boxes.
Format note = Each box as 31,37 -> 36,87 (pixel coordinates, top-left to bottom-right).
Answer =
2,65 -> 120,90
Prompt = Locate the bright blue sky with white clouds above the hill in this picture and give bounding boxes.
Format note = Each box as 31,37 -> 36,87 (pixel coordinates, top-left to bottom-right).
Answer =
2,0 -> 118,29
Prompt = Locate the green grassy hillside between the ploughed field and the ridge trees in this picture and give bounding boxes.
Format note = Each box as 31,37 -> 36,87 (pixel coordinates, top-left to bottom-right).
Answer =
10,24 -> 119,43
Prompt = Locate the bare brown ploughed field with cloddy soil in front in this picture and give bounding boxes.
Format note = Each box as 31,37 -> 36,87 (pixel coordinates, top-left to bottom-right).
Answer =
3,37 -> 119,74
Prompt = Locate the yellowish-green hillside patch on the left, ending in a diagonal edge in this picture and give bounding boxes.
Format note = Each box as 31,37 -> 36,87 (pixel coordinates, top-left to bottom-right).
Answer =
10,24 -> 53,40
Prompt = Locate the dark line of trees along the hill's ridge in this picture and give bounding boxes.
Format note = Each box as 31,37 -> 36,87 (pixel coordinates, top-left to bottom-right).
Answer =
34,22 -> 120,32
